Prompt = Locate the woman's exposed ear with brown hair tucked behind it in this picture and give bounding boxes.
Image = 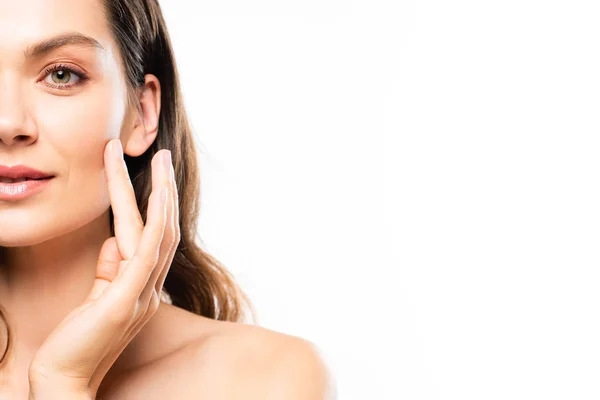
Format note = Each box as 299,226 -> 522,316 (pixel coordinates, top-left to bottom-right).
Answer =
121,74 -> 161,157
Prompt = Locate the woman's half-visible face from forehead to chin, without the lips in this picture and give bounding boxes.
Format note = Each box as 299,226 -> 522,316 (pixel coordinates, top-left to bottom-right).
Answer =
0,0 -> 135,247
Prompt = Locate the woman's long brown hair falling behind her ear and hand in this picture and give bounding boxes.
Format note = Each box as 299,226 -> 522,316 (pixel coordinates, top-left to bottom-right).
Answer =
0,0 -> 257,362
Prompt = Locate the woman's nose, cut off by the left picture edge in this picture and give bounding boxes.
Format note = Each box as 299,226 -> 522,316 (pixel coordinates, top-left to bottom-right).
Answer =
0,74 -> 37,147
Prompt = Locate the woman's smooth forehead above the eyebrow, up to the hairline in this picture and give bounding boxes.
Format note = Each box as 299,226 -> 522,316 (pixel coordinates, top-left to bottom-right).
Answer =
0,0 -> 114,57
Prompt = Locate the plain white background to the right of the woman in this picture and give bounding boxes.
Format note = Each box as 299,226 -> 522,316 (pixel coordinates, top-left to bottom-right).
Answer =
161,0 -> 600,400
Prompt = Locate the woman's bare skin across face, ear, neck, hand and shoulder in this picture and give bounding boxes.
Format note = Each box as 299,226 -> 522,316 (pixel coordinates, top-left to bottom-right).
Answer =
0,0 -> 331,400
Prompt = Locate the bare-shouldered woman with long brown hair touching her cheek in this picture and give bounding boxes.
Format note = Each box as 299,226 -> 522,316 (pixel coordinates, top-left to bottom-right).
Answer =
0,0 -> 327,400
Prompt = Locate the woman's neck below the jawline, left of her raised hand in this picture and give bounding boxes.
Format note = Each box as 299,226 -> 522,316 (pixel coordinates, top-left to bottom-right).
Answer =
0,210 -> 110,369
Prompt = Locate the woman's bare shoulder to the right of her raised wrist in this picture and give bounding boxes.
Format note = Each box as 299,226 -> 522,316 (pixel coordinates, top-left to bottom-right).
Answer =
98,304 -> 334,400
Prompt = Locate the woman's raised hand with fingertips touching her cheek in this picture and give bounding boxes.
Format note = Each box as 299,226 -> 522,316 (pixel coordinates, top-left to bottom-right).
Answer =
29,139 -> 180,397
